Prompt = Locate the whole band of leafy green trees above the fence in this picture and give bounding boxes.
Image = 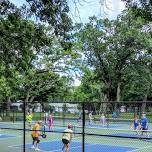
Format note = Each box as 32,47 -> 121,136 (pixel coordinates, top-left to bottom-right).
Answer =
0,0 -> 152,110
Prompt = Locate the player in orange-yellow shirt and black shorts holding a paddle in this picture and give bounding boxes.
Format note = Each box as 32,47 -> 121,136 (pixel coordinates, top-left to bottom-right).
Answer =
31,121 -> 42,151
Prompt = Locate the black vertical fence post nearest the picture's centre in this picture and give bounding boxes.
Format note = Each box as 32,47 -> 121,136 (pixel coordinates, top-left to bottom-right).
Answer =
82,102 -> 85,152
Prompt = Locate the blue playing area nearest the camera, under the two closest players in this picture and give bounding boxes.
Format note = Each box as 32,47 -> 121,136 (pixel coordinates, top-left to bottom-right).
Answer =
10,140 -> 138,152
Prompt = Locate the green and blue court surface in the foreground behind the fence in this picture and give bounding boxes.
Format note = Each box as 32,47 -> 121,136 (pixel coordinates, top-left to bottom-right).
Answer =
0,124 -> 152,152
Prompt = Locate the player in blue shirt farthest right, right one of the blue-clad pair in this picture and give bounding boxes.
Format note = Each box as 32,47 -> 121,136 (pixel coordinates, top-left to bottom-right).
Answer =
140,113 -> 148,135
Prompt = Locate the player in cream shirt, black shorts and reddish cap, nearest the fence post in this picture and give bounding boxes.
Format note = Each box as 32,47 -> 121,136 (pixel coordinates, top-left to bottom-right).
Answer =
62,124 -> 73,152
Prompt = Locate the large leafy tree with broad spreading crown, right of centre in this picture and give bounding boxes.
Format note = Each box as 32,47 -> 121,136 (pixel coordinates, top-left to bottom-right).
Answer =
74,12 -> 151,106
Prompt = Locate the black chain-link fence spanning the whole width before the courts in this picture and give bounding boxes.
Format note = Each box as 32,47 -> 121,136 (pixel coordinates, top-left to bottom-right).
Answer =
0,102 -> 152,152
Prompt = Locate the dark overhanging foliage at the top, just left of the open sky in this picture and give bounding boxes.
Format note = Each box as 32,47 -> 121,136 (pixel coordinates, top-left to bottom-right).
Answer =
26,0 -> 72,50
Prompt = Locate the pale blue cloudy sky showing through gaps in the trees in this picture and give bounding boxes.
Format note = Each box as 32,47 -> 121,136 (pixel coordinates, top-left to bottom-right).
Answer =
10,0 -> 125,86
